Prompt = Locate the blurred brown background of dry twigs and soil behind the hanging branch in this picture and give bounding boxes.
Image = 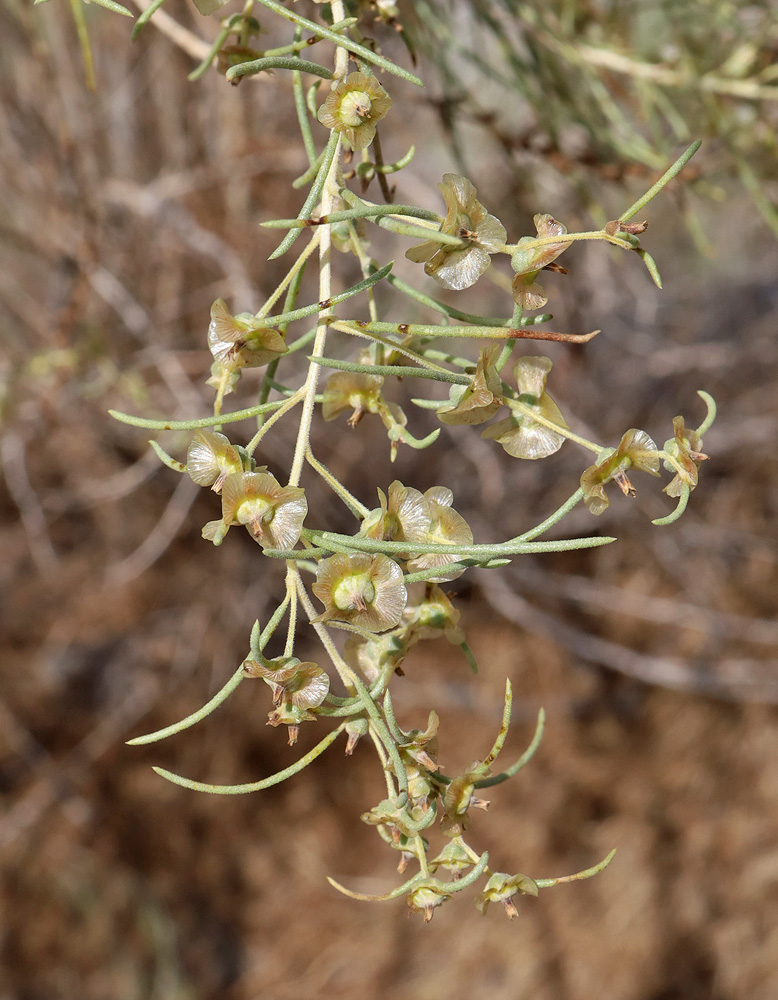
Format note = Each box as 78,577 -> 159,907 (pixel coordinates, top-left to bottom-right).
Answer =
0,0 -> 778,1000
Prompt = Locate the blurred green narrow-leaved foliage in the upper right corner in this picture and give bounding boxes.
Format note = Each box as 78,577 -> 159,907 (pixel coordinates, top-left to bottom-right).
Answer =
413,0 -> 778,245
